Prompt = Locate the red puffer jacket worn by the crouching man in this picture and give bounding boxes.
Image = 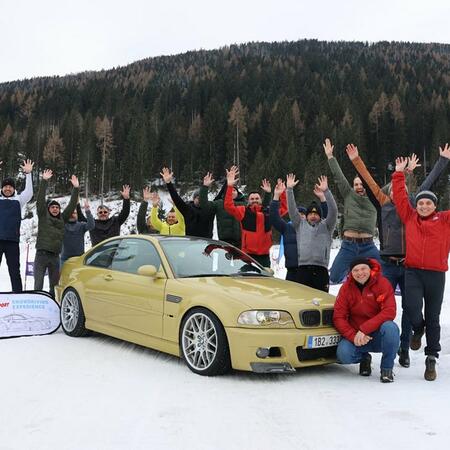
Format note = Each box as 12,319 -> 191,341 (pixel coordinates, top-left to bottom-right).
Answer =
333,259 -> 397,342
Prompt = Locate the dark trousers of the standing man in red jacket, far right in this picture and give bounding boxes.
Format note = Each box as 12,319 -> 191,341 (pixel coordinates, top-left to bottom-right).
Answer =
405,268 -> 445,357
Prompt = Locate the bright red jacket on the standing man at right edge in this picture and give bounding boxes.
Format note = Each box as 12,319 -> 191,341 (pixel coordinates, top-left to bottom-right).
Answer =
392,172 -> 450,272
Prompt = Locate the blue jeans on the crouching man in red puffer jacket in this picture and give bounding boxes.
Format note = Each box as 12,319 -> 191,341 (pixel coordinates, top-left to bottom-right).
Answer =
337,320 -> 400,369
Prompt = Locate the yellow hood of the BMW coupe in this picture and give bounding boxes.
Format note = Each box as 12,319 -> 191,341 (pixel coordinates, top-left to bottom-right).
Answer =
177,277 -> 335,312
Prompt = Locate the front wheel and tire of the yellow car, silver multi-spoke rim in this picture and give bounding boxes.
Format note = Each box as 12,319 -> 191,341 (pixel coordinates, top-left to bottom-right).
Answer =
180,308 -> 231,376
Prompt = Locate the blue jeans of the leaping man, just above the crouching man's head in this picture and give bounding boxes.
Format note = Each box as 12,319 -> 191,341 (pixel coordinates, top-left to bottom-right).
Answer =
330,239 -> 381,284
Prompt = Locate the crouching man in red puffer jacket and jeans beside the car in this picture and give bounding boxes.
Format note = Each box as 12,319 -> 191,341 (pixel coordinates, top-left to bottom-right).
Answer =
333,258 -> 400,383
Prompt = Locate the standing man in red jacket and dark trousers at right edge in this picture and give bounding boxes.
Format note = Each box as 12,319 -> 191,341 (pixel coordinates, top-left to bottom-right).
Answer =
392,154 -> 450,381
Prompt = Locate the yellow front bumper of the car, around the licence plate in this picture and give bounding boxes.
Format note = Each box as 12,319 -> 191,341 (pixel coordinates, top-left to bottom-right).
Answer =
225,327 -> 338,373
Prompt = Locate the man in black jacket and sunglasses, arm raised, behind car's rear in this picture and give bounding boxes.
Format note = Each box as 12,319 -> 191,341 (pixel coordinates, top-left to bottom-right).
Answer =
89,184 -> 130,246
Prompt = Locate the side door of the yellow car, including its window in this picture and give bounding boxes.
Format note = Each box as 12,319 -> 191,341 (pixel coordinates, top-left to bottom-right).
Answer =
101,238 -> 166,337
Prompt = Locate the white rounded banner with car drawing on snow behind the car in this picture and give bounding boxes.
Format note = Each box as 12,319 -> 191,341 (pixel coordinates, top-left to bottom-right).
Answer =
0,291 -> 61,338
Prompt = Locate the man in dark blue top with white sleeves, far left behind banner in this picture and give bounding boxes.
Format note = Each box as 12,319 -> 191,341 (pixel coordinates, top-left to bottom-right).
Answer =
0,159 -> 34,292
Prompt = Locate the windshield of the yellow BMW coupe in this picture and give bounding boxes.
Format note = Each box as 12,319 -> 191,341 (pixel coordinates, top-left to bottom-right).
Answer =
160,239 -> 272,278
